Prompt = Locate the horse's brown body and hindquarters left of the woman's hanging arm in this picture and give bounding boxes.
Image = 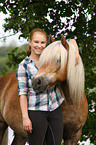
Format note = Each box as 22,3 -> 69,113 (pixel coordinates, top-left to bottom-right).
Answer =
0,72 -> 28,145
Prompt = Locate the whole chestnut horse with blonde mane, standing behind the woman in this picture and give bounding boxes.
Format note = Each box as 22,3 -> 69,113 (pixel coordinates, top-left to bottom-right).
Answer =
0,36 -> 88,145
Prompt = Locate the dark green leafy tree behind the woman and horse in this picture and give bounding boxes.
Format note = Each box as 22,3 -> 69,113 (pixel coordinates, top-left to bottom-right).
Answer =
0,0 -> 96,144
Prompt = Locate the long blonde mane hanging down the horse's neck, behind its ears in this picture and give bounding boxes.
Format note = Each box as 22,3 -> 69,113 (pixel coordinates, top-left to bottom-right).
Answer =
67,43 -> 85,103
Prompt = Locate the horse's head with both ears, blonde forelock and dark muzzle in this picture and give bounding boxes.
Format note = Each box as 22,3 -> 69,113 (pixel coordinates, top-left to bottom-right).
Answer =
32,35 -> 69,92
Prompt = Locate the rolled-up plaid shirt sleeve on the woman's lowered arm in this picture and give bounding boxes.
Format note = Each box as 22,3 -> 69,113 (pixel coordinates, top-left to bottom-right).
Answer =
16,64 -> 28,96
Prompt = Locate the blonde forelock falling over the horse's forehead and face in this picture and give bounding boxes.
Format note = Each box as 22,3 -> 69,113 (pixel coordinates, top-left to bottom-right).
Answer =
39,41 -> 67,69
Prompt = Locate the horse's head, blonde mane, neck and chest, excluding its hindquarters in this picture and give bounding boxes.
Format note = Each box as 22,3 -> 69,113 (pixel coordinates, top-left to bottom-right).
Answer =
32,35 -> 88,145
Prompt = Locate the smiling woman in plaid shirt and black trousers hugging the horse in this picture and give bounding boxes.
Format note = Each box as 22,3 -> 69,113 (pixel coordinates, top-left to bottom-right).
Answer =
16,28 -> 79,145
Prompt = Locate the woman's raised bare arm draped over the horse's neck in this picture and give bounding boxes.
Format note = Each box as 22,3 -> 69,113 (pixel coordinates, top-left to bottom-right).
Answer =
69,39 -> 79,65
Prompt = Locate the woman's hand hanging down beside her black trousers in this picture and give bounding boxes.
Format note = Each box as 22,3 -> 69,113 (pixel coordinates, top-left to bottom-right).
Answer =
23,117 -> 32,133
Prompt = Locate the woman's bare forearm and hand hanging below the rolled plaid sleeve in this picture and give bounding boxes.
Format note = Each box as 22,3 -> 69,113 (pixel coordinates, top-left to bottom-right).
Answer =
20,95 -> 32,133
